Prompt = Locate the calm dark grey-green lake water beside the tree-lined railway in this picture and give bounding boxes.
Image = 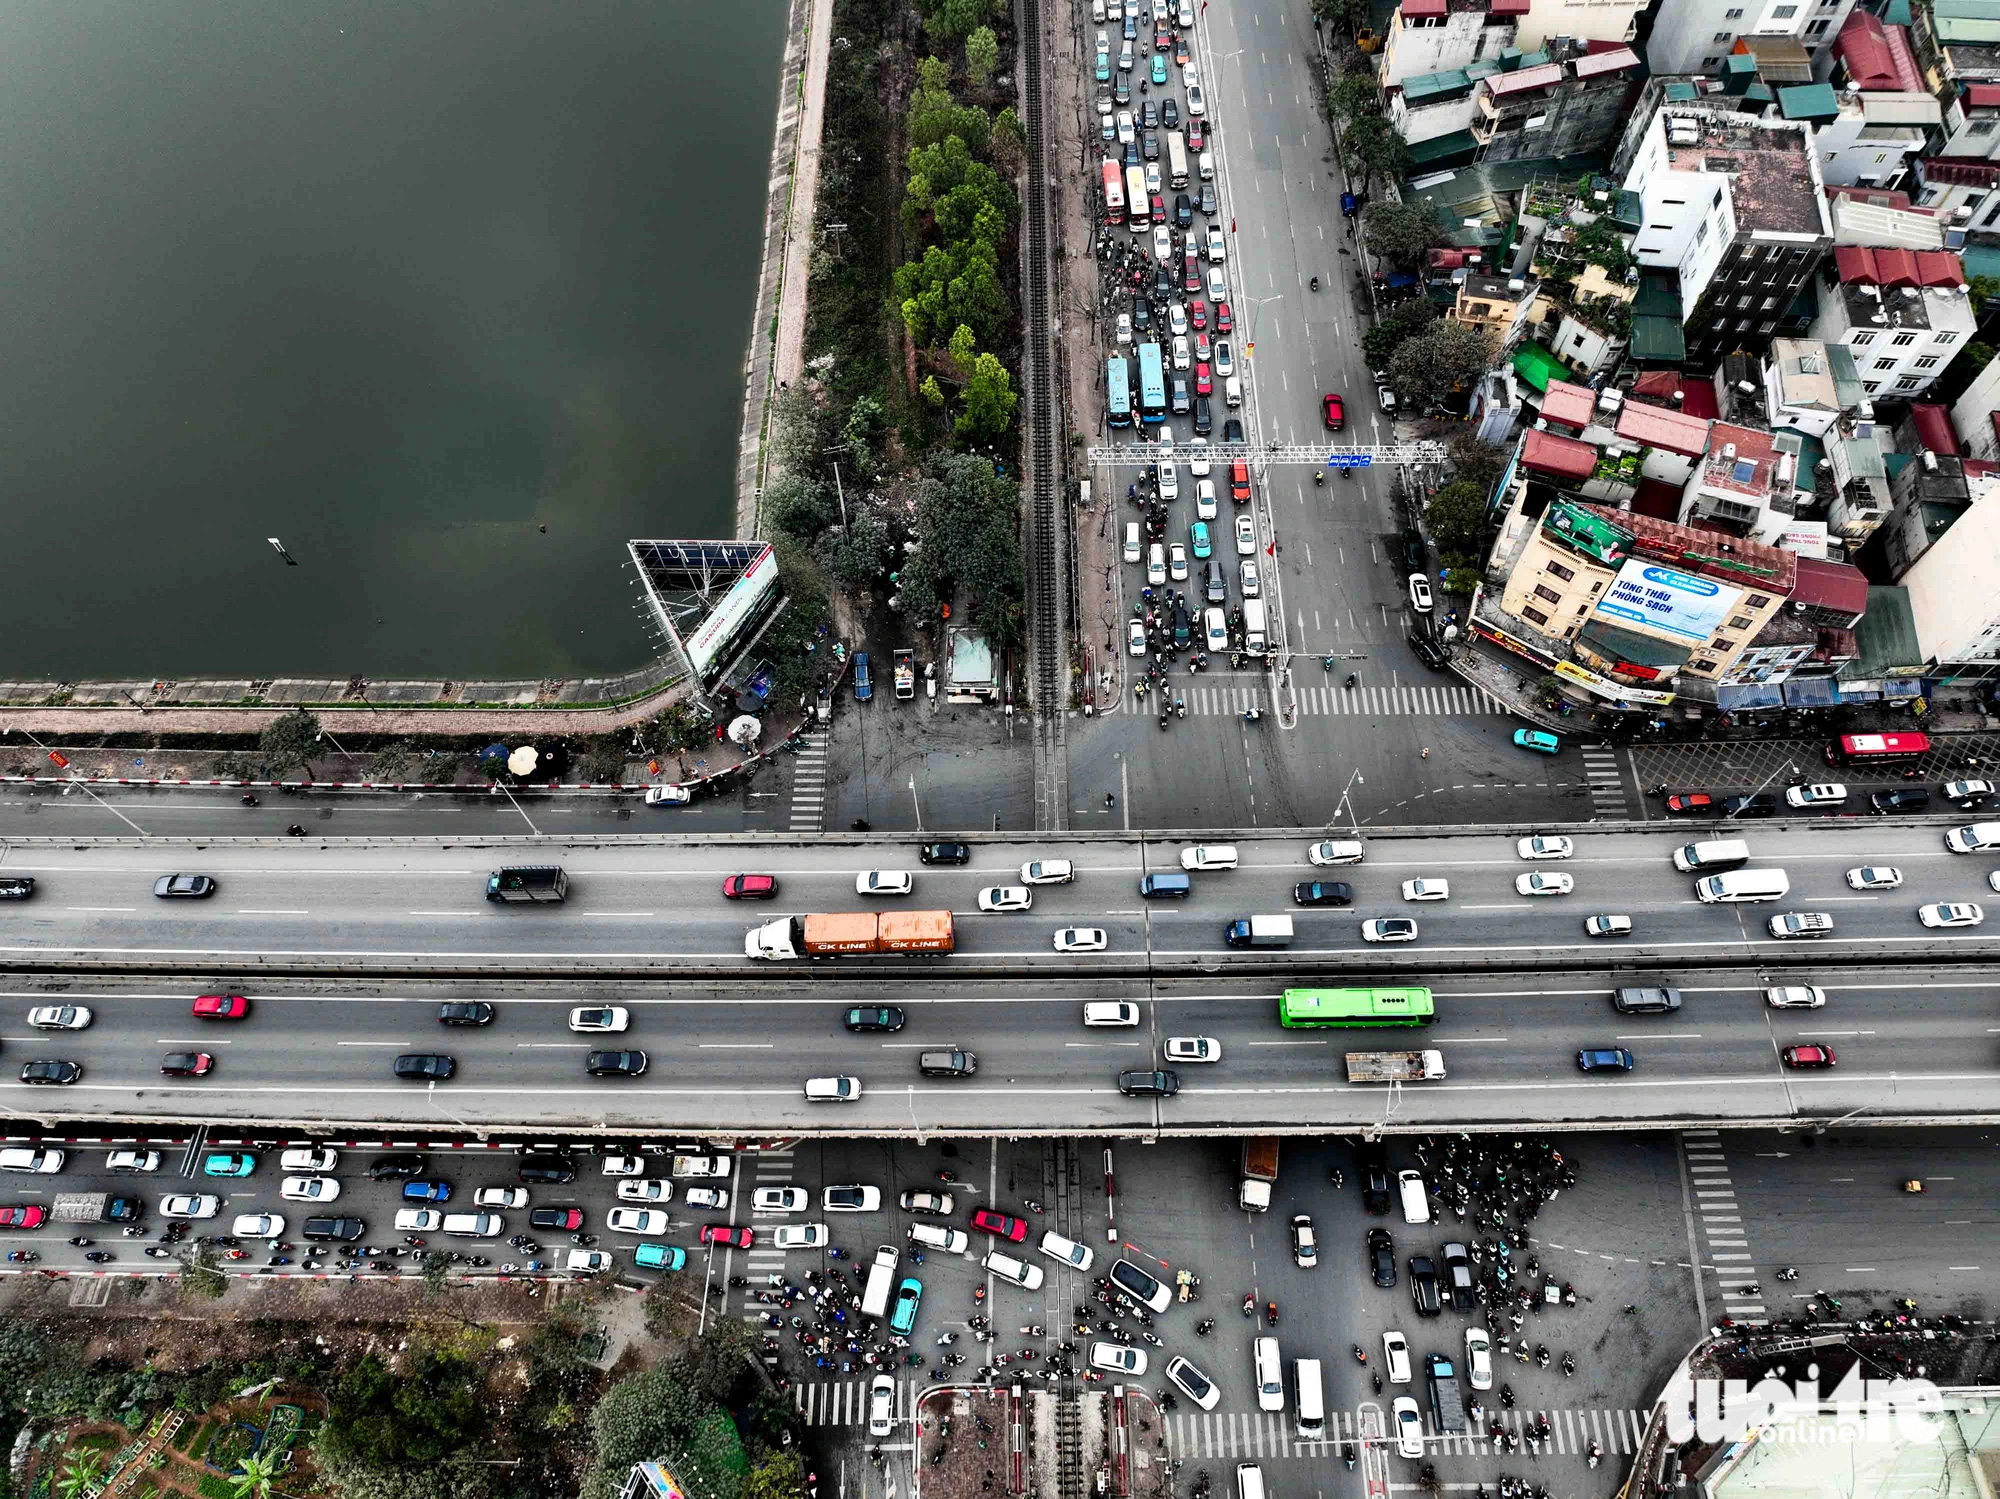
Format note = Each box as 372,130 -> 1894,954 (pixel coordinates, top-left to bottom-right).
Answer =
0,0 -> 786,680
